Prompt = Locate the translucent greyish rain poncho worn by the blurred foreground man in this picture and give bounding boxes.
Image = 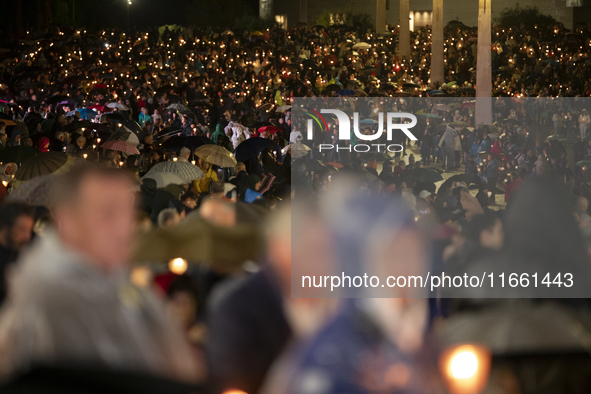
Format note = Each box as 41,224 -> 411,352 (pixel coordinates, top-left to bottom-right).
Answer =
0,233 -> 198,380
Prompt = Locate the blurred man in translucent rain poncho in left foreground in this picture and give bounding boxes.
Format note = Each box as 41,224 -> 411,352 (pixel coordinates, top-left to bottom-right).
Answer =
0,167 -> 199,381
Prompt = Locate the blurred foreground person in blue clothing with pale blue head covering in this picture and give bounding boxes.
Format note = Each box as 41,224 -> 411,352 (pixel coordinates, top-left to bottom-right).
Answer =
263,184 -> 437,394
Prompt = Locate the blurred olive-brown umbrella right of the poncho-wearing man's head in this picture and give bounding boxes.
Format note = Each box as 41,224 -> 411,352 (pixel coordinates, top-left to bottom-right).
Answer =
135,215 -> 261,272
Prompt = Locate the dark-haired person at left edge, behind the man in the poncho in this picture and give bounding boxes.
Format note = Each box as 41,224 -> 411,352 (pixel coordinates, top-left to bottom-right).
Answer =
0,203 -> 35,304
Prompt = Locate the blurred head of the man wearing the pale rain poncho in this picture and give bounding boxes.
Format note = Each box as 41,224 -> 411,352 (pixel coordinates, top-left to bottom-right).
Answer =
53,165 -> 135,271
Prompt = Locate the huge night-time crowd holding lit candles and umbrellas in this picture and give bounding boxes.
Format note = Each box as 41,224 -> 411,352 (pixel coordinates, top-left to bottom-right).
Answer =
0,16 -> 591,394
